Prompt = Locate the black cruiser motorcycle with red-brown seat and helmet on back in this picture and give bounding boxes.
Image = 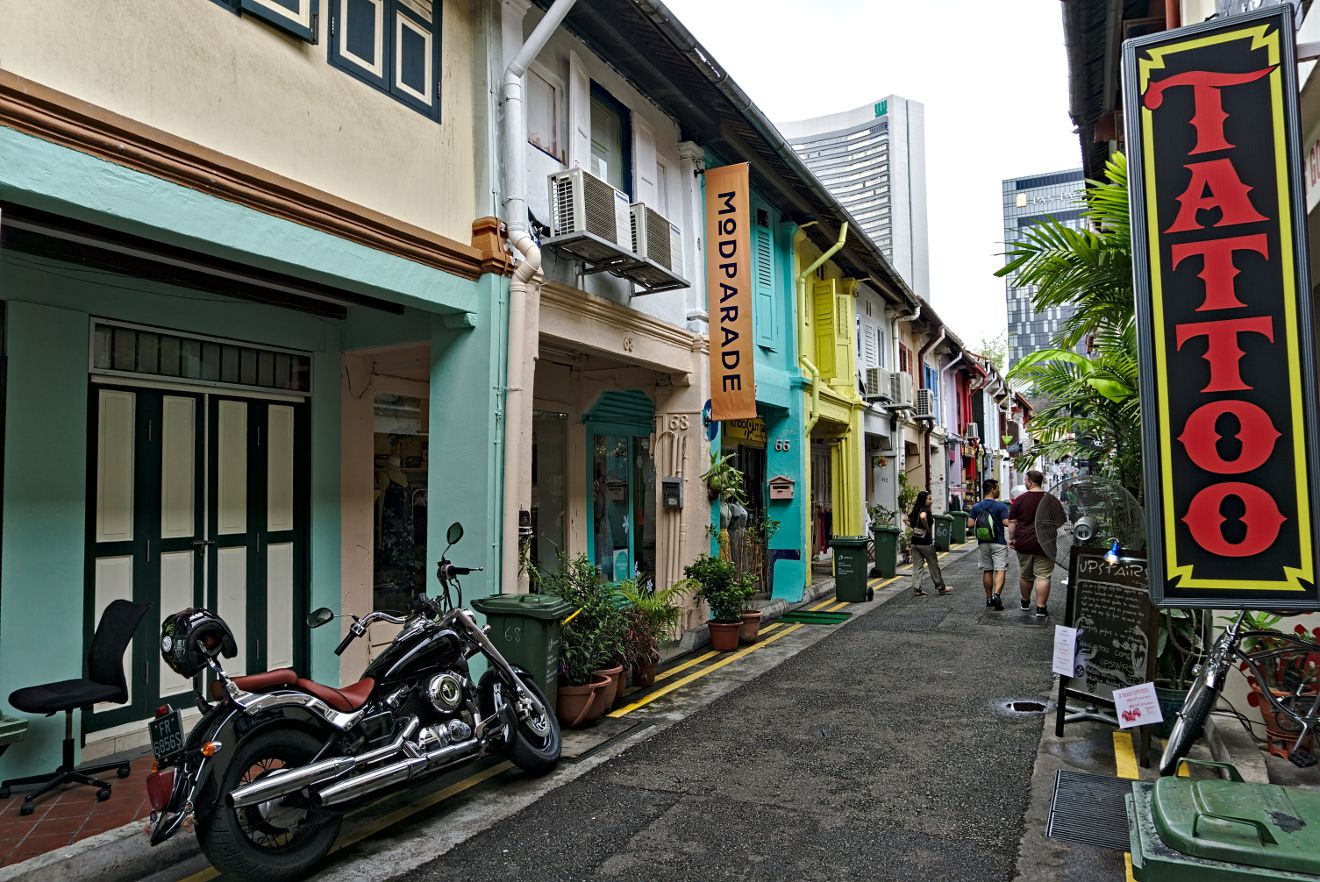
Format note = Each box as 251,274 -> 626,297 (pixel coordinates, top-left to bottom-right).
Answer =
147,523 -> 561,881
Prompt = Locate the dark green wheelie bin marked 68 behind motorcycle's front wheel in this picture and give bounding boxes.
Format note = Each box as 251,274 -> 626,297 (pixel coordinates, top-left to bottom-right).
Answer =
473,594 -> 573,708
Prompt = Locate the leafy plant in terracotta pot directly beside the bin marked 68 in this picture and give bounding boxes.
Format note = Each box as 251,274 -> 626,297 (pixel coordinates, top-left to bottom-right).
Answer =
532,553 -> 623,728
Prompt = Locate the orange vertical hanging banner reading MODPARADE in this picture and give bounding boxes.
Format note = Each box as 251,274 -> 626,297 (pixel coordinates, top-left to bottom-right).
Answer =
705,162 -> 756,420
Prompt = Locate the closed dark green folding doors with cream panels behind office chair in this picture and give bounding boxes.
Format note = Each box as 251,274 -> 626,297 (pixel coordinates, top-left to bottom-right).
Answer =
84,386 -> 309,730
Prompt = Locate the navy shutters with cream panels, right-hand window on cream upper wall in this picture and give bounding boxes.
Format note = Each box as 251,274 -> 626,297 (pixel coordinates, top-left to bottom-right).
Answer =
327,0 -> 441,120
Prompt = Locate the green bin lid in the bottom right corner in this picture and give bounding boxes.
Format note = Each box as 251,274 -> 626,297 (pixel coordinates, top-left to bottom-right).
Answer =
1151,778 -> 1320,879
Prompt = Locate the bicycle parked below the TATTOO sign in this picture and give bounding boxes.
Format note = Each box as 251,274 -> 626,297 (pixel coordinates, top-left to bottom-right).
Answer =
1159,613 -> 1320,775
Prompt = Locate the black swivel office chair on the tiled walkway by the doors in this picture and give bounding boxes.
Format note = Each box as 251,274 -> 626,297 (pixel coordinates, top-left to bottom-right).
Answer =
0,601 -> 150,815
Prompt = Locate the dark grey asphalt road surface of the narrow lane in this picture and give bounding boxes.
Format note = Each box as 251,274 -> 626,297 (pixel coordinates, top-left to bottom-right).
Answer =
399,552 -> 1063,882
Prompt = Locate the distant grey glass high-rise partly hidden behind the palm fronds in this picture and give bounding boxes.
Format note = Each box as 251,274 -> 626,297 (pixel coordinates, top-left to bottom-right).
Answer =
1003,169 -> 1085,367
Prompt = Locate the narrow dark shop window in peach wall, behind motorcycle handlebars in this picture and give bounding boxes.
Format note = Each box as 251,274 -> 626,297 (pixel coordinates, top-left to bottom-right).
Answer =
372,393 -> 429,611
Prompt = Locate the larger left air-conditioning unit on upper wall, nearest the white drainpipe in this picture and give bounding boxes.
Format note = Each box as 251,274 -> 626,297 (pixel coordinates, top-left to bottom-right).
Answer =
541,168 -> 636,271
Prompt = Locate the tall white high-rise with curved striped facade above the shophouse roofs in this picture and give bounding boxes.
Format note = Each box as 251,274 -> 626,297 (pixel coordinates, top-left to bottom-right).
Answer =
779,95 -> 931,297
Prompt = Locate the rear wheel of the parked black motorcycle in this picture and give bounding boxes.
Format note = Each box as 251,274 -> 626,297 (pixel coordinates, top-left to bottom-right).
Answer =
197,728 -> 343,882
